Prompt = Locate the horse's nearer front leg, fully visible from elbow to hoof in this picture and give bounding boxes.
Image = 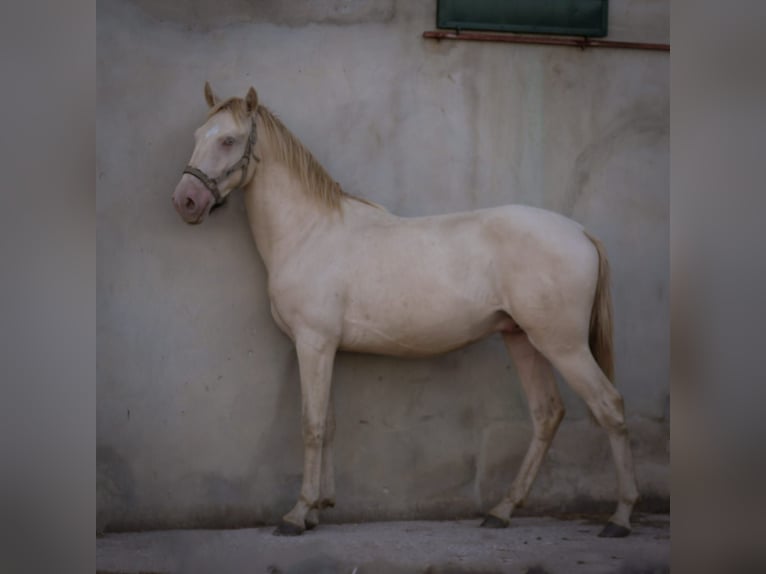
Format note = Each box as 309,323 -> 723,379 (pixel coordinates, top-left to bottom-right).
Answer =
274,333 -> 337,536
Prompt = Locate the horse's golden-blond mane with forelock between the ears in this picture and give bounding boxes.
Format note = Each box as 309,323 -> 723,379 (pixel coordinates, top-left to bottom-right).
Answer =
208,98 -> 384,210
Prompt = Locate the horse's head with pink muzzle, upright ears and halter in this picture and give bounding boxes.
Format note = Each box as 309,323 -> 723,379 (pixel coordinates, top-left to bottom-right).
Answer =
173,82 -> 258,223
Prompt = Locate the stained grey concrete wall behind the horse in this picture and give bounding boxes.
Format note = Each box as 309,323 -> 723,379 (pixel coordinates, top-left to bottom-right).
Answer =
97,0 -> 669,529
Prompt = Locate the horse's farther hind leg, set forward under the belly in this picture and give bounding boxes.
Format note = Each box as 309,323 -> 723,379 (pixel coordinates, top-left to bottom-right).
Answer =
482,333 -> 564,528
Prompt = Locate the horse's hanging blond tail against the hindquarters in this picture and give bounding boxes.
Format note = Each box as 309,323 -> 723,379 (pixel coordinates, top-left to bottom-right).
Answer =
585,231 -> 614,383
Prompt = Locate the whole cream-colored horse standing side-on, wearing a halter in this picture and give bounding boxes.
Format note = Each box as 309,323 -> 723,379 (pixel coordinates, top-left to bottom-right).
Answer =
173,84 -> 638,536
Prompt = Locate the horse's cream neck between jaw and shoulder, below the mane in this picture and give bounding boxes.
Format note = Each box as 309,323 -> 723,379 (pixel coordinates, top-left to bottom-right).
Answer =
245,157 -> 337,270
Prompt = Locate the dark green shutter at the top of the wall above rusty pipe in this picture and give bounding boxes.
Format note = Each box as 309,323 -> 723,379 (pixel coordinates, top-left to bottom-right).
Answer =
436,0 -> 608,37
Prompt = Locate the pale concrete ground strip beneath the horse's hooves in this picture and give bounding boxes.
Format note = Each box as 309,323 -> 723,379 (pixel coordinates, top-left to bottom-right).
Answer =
96,515 -> 670,574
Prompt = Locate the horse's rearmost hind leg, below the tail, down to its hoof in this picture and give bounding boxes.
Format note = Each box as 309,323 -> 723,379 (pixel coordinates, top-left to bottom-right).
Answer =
546,345 -> 638,537
